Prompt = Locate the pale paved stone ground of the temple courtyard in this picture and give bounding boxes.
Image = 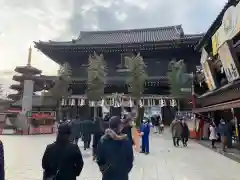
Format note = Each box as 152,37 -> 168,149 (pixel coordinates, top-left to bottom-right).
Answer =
0,132 -> 240,180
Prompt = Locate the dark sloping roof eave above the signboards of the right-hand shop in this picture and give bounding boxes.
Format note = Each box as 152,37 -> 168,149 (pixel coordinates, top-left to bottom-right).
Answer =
195,0 -> 239,51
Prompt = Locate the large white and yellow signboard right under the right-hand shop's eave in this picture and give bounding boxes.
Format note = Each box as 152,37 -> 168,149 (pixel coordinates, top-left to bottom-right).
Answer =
212,3 -> 240,55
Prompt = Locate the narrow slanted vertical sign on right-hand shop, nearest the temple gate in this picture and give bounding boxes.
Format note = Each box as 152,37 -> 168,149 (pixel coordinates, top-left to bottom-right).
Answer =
201,48 -> 216,90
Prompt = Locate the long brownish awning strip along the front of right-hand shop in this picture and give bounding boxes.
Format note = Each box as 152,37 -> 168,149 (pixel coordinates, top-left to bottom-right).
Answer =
193,99 -> 240,113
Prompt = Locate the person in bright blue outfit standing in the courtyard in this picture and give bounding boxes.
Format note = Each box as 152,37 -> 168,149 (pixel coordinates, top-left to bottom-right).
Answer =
140,119 -> 150,154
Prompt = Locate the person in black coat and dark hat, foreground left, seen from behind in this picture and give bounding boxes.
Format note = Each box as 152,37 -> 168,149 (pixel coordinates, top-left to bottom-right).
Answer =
42,124 -> 84,180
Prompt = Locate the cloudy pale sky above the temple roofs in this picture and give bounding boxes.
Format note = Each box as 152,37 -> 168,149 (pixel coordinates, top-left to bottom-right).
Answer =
0,0 -> 227,95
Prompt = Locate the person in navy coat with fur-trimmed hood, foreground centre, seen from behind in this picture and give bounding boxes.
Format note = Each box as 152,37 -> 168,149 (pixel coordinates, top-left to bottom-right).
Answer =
97,116 -> 133,180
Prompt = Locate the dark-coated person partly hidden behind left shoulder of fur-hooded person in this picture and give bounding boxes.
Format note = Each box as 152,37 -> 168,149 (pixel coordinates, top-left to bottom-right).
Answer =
92,117 -> 104,160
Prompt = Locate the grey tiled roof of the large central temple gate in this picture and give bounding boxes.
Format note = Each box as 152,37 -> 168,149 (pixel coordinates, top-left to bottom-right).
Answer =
36,25 -> 202,46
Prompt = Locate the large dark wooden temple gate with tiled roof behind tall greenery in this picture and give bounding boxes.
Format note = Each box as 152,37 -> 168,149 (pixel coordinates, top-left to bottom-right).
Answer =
35,25 -> 203,124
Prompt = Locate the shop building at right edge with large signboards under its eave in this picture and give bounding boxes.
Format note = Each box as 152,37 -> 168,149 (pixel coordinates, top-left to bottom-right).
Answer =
193,0 -> 240,143
